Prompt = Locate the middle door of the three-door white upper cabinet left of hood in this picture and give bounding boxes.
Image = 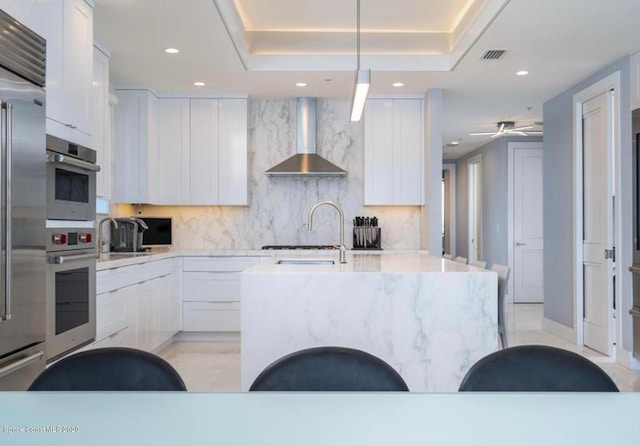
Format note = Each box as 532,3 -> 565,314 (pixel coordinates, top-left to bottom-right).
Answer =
189,99 -> 220,205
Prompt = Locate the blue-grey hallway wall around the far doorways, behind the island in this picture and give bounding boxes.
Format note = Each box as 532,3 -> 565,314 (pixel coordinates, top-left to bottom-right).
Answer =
455,136 -> 542,266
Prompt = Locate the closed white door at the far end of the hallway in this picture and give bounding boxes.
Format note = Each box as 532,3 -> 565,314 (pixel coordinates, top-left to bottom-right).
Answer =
511,147 -> 544,303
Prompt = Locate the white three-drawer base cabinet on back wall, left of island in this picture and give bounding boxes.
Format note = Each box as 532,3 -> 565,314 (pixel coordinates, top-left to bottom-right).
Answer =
182,257 -> 260,332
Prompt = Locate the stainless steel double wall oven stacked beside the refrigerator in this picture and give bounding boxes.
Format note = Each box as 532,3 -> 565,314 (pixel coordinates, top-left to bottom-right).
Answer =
46,135 -> 100,361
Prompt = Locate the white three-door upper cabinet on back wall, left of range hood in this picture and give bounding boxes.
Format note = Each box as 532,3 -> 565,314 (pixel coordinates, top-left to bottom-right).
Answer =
158,98 -> 248,205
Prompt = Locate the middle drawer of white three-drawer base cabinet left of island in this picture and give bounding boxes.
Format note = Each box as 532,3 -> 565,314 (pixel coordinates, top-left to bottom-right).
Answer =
182,271 -> 240,302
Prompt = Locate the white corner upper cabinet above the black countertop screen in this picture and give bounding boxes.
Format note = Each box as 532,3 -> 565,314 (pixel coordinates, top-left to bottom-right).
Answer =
114,90 -> 158,204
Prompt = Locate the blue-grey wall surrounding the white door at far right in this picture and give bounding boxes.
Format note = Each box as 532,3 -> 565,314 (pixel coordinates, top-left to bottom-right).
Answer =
543,57 -> 632,350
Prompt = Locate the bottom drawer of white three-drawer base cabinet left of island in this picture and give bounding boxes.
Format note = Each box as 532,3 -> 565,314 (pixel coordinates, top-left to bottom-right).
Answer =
182,302 -> 240,331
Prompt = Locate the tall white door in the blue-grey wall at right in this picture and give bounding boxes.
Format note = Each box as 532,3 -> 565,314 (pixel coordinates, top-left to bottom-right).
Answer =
582,91 -> 615,355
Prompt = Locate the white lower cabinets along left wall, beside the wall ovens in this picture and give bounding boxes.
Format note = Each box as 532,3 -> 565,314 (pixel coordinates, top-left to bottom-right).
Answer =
91,259 -> 180,351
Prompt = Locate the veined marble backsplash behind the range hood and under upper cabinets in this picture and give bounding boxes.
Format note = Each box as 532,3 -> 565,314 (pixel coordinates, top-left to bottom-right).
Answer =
115,99 -> 420,250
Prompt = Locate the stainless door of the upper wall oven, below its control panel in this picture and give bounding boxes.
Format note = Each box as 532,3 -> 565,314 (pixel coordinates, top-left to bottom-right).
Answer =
47,151 -> 100,221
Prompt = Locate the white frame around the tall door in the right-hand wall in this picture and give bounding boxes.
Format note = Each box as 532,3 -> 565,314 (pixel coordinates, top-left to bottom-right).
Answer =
573,71 -> 622,350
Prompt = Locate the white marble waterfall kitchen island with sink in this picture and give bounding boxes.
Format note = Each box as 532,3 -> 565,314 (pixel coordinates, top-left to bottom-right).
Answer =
241,252 -> 498,392
